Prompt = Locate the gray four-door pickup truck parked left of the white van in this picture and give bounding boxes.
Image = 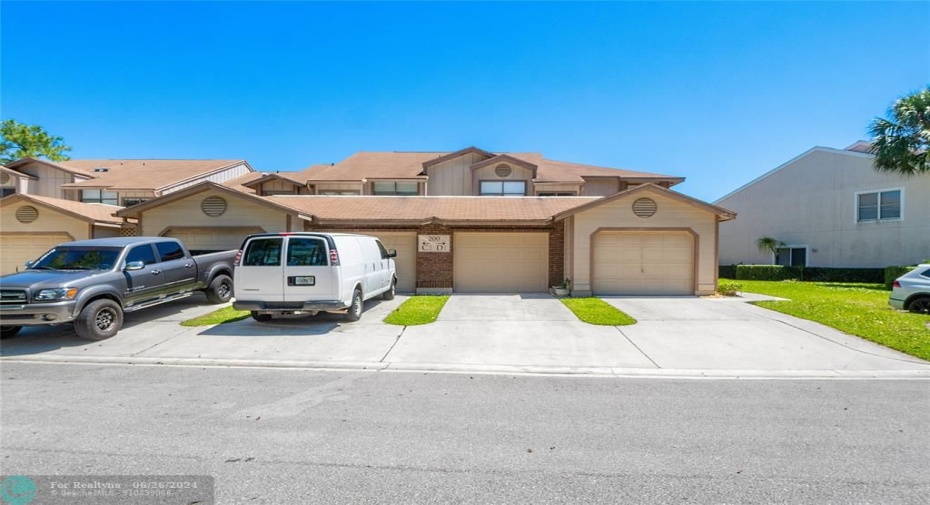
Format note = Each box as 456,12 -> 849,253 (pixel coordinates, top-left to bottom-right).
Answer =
0,237 -> 237,340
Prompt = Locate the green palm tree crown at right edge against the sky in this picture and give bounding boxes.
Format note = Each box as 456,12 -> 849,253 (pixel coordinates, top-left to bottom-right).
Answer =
869,86 -> 930,175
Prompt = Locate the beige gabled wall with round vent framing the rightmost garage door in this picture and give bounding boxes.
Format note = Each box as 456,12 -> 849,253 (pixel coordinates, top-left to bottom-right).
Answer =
566,192 -> 717,295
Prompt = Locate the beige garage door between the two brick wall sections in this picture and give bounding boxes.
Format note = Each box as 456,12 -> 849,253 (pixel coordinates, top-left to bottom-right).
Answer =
454,232 -> 549,293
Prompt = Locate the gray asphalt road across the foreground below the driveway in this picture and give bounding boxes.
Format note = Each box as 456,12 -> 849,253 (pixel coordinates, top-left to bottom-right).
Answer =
0,363 -> 930,504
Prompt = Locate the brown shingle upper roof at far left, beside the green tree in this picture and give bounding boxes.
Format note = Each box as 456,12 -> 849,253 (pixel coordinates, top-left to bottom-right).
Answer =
57,160 -> 246,190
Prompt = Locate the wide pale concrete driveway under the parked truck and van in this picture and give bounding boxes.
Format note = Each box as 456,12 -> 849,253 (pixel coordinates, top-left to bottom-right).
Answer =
0,295 -> 930,377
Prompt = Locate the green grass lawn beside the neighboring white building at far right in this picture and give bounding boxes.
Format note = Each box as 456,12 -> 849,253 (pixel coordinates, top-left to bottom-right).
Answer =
721,279 -> 930,360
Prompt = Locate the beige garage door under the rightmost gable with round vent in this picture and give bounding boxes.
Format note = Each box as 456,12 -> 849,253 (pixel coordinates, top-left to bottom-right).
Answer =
591,232 -> 694,295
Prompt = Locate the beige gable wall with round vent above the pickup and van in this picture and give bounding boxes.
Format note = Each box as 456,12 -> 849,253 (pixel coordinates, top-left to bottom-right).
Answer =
138,190 -> 296,235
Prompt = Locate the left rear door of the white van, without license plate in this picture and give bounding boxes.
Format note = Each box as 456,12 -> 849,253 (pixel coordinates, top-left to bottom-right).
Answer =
233,237 -> 284,302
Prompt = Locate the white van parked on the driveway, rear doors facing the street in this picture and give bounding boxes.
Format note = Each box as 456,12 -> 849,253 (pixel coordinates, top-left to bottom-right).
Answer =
233,232 -> 397,321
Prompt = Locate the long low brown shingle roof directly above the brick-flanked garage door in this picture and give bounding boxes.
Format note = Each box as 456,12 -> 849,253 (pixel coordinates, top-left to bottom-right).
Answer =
266,196 -> 598,223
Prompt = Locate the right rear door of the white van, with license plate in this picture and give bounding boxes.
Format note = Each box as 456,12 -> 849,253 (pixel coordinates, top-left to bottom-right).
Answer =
283,235 -> 341,302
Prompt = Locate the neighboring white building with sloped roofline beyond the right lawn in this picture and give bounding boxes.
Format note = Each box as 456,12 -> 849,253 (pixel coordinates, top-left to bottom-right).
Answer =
714,141 -> 930,268
